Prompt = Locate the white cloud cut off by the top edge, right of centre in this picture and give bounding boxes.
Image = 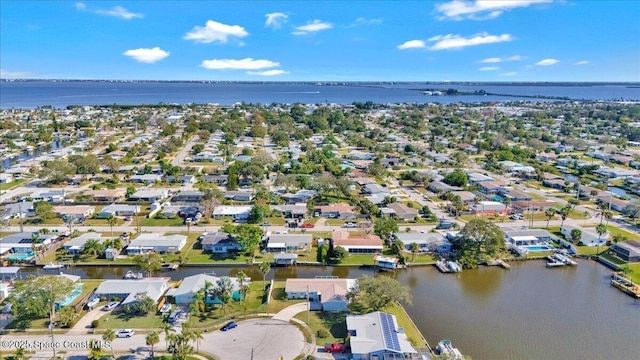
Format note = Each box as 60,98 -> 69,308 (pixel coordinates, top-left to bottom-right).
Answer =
436,0 -> 553,20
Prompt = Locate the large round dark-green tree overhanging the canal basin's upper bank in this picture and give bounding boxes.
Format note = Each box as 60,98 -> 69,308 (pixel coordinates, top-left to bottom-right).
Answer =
452,218 -> 505,269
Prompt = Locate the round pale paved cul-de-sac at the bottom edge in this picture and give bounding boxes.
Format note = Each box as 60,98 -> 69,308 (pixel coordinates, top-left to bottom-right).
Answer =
200,319 -> 305,360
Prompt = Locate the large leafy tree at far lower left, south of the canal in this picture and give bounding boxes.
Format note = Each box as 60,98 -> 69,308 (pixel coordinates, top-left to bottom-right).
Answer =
11,275 -> 76,322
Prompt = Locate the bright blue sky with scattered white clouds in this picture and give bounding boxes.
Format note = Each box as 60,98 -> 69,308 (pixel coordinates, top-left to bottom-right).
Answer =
0,0 -> 640,81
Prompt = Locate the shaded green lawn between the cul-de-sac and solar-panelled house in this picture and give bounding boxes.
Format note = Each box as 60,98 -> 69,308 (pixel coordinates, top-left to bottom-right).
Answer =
295,311 -> 347,346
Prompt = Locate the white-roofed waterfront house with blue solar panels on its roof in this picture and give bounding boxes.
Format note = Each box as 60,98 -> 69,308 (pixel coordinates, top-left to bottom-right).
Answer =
346,311 -> 418,360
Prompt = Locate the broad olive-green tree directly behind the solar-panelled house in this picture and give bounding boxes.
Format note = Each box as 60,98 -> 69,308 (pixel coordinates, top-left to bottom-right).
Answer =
347,276 -> 412,311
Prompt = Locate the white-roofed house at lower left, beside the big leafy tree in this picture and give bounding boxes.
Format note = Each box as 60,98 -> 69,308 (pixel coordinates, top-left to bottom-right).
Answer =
94,277 -> 170,305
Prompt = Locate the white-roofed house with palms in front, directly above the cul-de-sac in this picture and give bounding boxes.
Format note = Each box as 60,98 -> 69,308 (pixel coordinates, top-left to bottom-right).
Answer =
167,274 -> 245,304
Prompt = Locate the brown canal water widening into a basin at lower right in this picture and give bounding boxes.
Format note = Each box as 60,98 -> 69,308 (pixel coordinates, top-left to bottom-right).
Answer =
22,261 -> 640,360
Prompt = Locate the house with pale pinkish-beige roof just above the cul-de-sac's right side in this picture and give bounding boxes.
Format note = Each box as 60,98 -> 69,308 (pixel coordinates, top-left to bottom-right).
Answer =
284,278 -> 356,311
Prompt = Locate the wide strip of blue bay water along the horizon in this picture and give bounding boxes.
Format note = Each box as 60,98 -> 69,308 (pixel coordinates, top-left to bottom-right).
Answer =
0,81 -> 640,109
